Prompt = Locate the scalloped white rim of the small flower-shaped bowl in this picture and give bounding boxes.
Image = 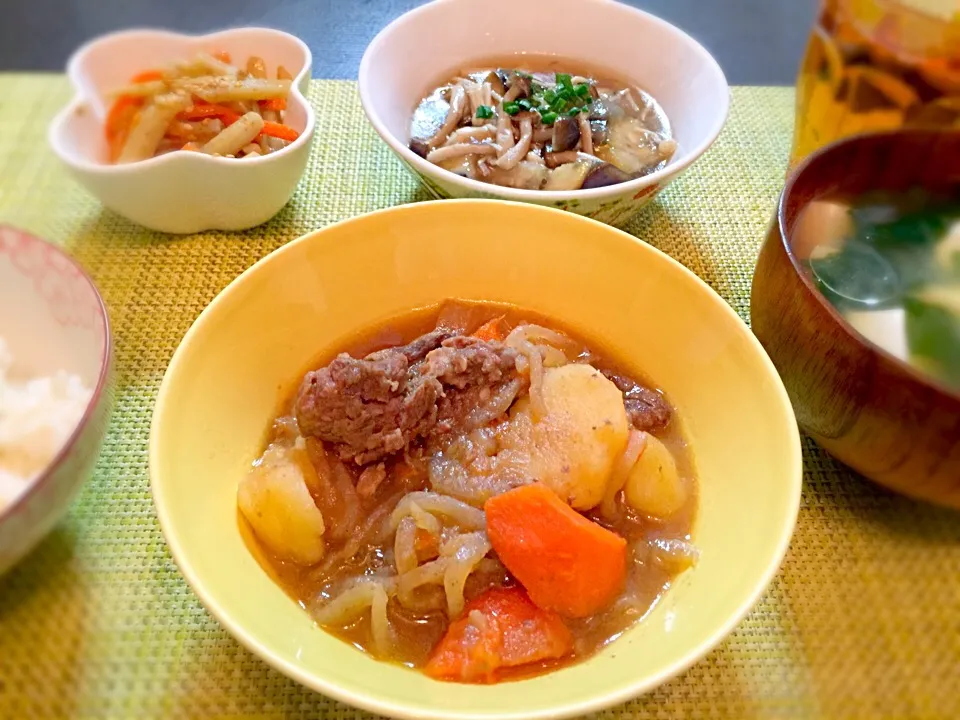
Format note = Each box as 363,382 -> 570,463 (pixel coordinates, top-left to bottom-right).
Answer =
47,25 -> 316,175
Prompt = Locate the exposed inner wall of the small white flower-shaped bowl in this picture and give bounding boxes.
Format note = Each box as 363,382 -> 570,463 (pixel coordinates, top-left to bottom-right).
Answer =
51,28 -> 311,163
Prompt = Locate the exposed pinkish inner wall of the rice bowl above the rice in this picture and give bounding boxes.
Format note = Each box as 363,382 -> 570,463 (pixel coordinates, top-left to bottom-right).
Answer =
0,226 -> 107,388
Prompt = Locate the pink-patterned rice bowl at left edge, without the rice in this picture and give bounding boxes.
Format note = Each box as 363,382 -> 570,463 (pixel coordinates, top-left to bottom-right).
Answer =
0,226 -> 113,573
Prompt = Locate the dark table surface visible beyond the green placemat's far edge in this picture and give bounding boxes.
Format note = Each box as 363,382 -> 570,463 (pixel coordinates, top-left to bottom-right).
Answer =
0,0 -> 818,85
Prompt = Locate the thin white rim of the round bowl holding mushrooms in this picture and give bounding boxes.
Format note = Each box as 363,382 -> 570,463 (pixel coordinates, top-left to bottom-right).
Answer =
358,0 -> 730,202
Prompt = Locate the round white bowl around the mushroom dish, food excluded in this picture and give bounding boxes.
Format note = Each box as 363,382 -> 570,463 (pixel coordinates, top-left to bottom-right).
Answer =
360,0 -> 730,225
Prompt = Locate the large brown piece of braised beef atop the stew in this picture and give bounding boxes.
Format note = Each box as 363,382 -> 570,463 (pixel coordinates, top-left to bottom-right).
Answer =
295,330 -> 518,464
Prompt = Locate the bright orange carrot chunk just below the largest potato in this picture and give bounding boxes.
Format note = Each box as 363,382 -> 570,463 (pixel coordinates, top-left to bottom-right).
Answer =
484,483 -> 627,618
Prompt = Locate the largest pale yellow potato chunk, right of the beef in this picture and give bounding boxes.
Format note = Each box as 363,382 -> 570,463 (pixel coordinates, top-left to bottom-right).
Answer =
498,364 -> 628,510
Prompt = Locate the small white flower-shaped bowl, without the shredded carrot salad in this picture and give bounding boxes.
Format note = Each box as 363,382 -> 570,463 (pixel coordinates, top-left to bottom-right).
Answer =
48,28 -> 315,234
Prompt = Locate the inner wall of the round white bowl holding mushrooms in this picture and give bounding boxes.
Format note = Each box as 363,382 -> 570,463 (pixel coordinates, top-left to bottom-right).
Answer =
360,0 -> 728,176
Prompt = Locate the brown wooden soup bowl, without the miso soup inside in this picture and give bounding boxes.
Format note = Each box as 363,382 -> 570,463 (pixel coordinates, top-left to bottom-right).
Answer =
751,131 -> 960,508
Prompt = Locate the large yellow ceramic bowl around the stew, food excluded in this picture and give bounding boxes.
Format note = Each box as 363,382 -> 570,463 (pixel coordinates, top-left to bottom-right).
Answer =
150,200 -> 801,720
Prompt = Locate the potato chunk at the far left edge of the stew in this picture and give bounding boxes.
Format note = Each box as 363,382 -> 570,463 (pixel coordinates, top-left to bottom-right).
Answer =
237,446 -> 325,565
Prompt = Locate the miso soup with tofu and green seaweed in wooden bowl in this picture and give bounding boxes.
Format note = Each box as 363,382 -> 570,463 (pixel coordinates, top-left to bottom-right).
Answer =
794,190 -> 960,389
